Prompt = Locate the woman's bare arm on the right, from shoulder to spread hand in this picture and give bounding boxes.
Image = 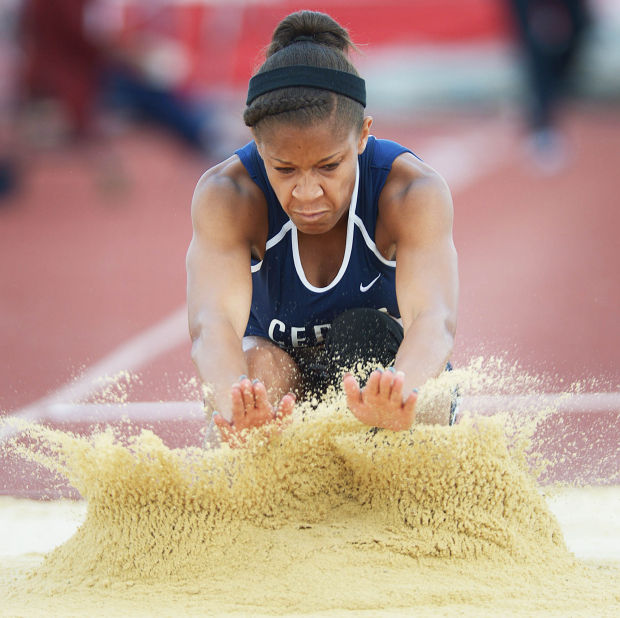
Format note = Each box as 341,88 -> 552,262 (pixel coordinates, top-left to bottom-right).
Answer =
343,155 -> 458,431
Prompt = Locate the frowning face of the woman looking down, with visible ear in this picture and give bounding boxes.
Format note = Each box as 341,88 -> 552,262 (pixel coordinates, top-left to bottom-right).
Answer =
255,116 -> 372,234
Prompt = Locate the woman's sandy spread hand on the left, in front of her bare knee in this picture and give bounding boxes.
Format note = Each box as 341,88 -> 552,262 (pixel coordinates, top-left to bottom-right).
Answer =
213,376 -> 296,448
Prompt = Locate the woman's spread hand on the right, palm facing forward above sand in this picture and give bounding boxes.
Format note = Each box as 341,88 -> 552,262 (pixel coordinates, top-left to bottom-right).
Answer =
342,369 -> 418,431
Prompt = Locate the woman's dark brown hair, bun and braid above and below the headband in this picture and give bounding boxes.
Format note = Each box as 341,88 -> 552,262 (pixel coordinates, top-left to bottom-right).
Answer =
243,11 -> 364,132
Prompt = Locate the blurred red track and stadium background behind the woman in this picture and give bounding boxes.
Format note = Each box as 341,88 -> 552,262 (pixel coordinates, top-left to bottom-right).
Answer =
0,0 -> 620,417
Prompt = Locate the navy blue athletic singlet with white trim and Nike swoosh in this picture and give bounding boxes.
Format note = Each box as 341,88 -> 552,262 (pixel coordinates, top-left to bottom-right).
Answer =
236,136 -> 411,348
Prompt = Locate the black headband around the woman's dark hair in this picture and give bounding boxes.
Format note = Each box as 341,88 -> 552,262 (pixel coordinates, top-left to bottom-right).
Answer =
245,64 -> 366,107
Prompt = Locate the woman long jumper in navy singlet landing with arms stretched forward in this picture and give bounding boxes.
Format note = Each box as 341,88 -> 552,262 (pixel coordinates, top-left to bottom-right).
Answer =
187,11 -> 458,442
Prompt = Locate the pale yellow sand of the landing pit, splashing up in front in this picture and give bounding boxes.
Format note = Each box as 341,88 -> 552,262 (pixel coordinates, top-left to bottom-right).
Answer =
0,364 -> 620,616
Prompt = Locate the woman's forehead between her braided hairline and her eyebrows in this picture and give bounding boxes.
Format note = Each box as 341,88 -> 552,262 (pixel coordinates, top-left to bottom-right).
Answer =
255,122 -> 356,165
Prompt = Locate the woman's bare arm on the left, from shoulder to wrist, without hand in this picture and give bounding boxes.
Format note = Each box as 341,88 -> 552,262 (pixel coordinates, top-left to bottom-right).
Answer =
186,160 -> 252,421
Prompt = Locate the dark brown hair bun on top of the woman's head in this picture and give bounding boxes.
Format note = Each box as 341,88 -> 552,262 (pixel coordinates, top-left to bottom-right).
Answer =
266,11 -> 355,58
